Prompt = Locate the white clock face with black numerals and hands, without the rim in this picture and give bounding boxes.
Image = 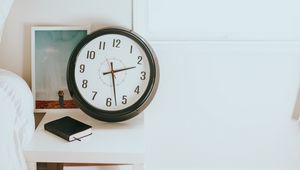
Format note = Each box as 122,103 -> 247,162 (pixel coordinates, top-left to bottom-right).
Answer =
74,34 -> 150,111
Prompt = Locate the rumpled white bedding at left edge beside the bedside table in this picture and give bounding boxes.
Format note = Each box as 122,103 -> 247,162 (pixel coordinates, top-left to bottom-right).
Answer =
0,69 -> 34,170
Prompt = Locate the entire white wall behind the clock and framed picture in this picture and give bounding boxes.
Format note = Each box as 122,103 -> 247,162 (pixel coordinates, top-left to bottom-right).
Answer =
0,0 -> 300,170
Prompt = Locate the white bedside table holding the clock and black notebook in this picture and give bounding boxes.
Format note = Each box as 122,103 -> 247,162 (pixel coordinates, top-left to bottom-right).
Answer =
24,109 -> 144,170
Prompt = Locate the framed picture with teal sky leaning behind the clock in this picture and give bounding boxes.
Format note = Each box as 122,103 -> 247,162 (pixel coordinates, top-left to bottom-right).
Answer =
31,26 -> 90,111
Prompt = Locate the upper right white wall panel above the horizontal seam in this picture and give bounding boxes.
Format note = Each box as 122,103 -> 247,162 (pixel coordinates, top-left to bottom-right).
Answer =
134,0 -> 300,41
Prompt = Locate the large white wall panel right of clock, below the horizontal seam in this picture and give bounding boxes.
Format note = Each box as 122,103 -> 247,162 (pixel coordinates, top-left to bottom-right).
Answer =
145,42 -> 300,170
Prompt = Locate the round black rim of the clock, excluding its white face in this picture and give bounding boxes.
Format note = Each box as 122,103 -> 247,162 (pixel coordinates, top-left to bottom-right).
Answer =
67,27 -> 159,122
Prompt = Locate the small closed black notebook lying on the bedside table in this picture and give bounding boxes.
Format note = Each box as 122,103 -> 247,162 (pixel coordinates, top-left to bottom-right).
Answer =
44,116 -> 92,142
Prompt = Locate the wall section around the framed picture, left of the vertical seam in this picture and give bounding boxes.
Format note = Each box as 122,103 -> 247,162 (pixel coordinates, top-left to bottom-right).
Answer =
0,0 -> 132,84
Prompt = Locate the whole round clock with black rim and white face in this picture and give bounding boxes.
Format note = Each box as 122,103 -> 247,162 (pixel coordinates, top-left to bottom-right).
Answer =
67,28 -> 159,122
